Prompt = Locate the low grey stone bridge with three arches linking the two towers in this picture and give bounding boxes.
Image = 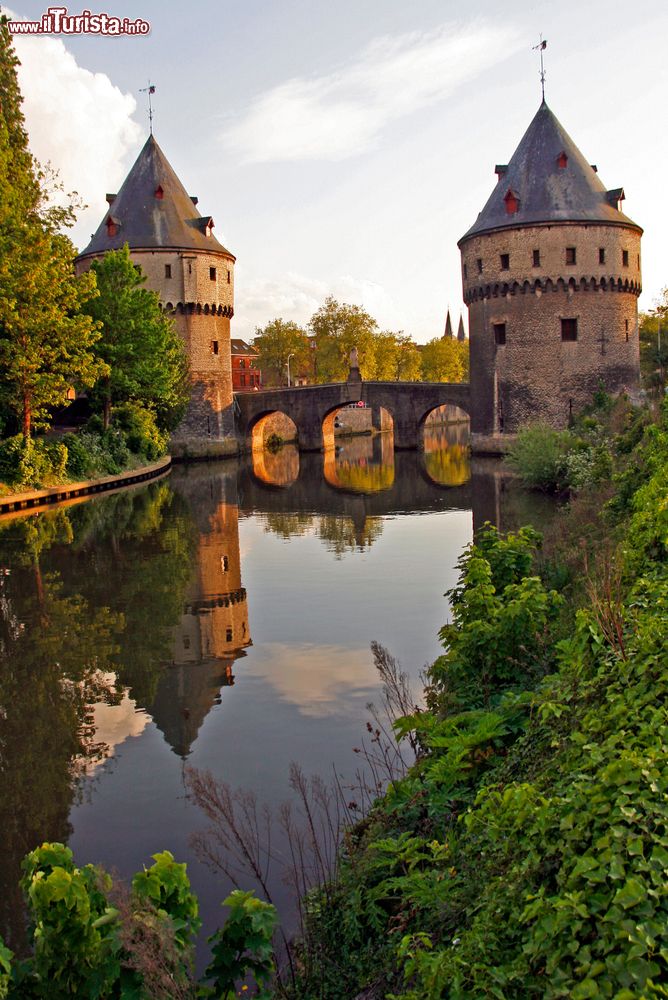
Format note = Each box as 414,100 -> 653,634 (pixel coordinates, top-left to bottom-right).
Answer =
234,379 -> 471,451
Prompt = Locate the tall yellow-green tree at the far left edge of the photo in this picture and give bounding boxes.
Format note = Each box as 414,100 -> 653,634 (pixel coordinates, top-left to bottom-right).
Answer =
0,17 -> 106,438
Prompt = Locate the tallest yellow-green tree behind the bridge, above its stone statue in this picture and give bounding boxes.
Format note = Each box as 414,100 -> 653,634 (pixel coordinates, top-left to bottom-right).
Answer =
309,295 -> 378,382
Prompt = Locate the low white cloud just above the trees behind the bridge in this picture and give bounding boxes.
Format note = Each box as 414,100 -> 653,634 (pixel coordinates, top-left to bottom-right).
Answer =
234,266 -> 399,339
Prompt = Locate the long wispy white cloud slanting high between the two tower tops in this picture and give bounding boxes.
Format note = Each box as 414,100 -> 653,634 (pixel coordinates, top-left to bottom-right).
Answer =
223,22 -> 522,162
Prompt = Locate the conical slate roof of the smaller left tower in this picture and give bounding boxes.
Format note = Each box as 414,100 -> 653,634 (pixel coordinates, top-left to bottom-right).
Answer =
80,135 -> 232,257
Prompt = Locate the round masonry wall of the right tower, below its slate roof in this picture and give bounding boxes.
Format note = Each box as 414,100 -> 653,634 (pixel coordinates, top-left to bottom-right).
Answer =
462,224 -> 641,433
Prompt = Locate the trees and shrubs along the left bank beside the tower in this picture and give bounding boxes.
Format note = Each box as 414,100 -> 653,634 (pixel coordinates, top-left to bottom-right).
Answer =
0,16 -> 188,492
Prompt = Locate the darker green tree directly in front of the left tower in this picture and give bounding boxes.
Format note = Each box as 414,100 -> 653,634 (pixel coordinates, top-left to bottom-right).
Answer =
85,243 -> 189,429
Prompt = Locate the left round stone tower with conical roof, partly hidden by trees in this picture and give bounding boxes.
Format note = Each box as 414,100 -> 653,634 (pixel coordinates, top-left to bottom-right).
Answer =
77,135 -> 235,455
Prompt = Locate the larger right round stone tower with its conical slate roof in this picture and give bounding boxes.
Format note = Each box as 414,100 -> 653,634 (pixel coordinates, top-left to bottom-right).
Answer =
459,101 -> 642,443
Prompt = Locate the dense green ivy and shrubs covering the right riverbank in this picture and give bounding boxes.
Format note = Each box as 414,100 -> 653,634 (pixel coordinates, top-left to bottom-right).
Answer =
254,404 -> 668,1000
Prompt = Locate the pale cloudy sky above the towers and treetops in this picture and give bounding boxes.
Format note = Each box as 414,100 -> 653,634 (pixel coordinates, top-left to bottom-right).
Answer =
3,0 -> 668,343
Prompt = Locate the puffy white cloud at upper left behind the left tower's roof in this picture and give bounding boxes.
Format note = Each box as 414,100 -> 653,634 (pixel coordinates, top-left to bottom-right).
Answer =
9,17 -> 141,243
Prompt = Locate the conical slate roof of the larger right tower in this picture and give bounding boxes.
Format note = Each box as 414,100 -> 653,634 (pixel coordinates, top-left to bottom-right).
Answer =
459,101 -> 642,245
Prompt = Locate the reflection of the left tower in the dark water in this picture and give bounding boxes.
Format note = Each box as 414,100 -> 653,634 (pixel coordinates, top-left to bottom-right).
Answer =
146,467 -> 251,758
